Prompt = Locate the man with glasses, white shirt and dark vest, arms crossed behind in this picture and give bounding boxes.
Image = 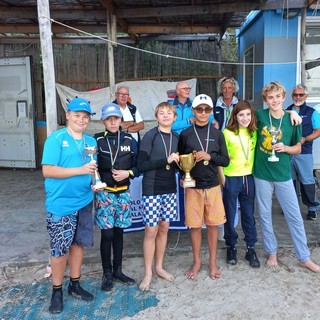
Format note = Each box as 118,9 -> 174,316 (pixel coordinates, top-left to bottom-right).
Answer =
113,85 -> 144,142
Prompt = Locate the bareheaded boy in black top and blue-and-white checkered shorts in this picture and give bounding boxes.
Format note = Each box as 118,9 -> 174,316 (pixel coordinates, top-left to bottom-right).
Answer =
138,102 -> 179,291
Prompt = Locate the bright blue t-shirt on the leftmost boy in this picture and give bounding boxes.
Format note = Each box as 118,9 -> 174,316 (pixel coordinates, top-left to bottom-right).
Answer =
42,128 -> 97,216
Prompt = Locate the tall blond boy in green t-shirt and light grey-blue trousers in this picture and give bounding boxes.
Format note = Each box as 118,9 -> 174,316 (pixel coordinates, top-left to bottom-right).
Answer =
253,81 -> 320,272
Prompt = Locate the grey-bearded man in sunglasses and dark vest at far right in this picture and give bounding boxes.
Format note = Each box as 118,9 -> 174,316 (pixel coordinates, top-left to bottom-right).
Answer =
287,84 -> 320,220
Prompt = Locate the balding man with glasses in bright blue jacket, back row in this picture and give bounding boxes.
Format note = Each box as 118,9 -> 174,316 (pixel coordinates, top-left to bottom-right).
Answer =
172,81 -> 214,134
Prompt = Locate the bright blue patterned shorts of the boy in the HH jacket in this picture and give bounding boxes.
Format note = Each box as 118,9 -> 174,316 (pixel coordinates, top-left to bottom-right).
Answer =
94,190 -> 132,229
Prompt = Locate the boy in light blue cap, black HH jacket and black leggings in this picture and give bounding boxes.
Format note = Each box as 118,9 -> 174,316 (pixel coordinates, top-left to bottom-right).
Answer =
95,103 -> 139,291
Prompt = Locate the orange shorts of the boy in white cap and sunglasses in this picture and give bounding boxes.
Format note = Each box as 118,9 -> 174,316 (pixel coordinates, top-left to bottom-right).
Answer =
185,186 -> 226,228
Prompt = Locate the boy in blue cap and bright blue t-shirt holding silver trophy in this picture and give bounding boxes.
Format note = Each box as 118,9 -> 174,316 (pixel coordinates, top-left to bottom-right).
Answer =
42,98 -> 97,313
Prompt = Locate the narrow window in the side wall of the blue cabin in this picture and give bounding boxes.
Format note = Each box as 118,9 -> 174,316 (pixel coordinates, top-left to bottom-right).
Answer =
243,46 -> 254,101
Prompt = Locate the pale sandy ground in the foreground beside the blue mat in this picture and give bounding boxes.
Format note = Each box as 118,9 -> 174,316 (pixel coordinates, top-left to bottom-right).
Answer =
0,246 -> 320,320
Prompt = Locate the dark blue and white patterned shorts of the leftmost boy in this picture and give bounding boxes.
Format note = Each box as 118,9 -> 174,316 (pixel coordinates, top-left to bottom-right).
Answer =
47,202 -> 93,257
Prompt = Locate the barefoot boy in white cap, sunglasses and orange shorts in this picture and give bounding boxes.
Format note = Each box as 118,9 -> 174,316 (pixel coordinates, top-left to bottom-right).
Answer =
178,94 -> 229,279
